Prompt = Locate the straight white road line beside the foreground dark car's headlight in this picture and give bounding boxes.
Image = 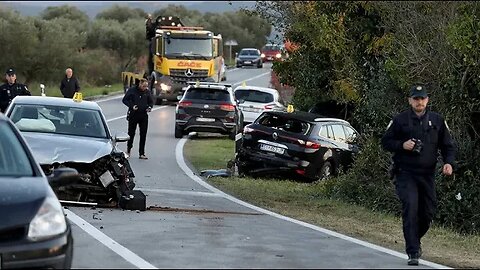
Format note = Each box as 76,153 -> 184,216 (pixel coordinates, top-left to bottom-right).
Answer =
64,209 -> 158,269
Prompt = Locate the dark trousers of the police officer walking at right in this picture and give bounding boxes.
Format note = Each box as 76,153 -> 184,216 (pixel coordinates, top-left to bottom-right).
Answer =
395,170 -> 437,254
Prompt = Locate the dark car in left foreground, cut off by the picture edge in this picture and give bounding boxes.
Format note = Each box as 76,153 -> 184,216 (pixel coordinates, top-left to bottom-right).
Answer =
0,114 -> 73,269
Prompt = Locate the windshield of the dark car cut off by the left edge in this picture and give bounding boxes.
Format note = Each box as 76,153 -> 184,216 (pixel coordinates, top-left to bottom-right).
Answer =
0,122 -> 33,177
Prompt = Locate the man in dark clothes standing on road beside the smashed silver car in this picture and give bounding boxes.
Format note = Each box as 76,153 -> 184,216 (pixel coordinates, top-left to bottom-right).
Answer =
122,78 -> 153,159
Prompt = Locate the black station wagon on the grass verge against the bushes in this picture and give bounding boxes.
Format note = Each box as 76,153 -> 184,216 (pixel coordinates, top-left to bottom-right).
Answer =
237,111 -> 358,181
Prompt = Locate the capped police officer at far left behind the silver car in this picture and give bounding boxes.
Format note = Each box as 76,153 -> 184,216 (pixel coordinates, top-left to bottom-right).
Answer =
0,68 -> 32,113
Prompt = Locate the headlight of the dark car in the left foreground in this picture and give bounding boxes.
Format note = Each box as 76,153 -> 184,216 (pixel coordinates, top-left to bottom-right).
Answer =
28,197 -> 67,241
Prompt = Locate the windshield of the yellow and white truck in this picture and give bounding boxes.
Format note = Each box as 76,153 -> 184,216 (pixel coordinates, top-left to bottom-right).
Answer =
165,37 -> 213,59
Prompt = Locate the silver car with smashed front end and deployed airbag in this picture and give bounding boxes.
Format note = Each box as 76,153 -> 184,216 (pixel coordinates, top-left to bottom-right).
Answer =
6,97 -> 135,205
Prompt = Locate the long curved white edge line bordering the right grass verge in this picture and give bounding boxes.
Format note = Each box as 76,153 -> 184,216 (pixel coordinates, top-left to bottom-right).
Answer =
175,138 -> 452,269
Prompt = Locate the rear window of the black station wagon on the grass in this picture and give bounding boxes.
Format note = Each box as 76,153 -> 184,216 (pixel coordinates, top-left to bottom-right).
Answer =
256,113 -> 310,135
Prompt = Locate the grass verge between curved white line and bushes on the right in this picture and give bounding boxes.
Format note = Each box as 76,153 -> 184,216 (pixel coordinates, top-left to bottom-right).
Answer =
184,138 -> 480,268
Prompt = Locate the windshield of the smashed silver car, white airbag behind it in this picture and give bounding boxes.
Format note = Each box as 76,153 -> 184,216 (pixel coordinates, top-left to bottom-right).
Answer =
10,105 -> 107,138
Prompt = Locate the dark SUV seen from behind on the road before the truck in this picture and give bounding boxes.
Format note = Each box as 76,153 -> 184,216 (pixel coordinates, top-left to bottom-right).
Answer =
175,82 -> 243,140
